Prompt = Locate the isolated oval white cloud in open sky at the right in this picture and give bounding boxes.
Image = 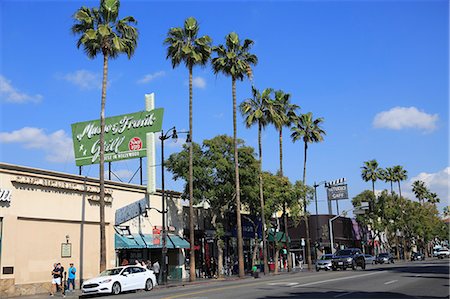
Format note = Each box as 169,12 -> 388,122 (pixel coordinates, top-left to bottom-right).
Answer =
373,107 -> 439,132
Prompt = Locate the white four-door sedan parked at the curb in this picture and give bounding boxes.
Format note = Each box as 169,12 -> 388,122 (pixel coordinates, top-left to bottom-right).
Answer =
81,265 -> 156,295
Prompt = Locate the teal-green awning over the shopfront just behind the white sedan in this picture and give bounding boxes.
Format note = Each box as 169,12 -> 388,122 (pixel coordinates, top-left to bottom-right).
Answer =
114,233 -> 190,249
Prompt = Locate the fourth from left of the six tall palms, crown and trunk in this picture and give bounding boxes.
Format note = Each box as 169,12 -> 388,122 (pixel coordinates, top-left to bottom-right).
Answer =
239,87 -> 274,274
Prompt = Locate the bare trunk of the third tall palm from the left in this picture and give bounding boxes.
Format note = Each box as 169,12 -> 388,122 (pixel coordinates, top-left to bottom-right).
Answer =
231,77 -> 245,278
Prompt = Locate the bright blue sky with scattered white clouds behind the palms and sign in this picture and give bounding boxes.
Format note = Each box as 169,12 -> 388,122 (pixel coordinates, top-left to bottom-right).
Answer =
0,0 -> 450,213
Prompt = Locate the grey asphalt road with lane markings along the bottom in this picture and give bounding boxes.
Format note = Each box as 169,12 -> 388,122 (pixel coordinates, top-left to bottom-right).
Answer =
82,259 -> 450,299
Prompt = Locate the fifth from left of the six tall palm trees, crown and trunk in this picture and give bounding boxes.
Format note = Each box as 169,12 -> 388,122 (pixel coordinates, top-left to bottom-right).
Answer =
271,90 -> 300,271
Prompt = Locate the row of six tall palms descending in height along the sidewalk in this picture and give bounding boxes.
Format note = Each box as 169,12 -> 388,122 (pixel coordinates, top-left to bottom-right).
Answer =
72,0 -> 324,281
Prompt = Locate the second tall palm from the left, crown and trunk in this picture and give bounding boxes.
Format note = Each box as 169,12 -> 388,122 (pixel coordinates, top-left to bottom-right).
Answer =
164,17 -> 212,281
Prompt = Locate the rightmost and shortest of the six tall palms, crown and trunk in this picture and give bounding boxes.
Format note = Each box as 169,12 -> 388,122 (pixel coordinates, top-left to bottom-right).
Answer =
291,112 -> 325,270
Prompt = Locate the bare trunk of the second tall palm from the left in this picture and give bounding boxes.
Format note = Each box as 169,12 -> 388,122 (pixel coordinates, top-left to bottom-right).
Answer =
189,66 -> 196,281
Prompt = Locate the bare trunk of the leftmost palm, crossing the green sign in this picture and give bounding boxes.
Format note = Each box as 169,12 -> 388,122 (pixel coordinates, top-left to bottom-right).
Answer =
99,53 -> 108,272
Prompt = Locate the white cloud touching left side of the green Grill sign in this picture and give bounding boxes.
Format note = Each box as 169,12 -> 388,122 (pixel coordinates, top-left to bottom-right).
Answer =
0,127 -> 74,163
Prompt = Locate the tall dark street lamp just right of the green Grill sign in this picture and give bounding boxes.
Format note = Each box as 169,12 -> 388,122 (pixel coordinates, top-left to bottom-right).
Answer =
159,127 -> 191,284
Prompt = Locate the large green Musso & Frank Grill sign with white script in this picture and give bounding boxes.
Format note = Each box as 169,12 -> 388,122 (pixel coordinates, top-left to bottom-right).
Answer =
72,108 -> 164,166
